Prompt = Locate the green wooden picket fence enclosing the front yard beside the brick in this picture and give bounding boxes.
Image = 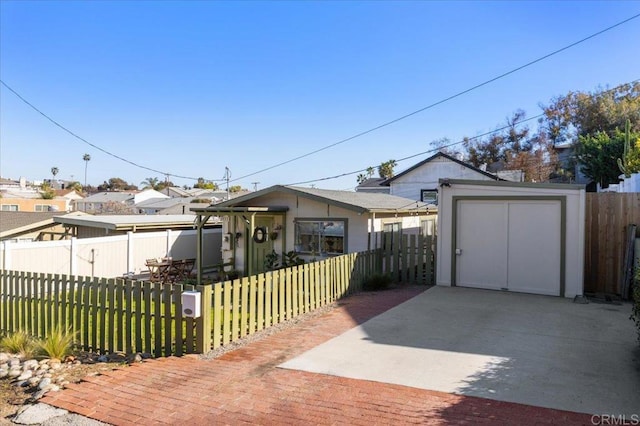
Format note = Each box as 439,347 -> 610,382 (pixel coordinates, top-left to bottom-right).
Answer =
0,243 -> 435,357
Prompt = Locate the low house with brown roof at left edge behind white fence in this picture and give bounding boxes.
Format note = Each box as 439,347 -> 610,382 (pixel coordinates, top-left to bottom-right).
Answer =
0,211 -> 86,241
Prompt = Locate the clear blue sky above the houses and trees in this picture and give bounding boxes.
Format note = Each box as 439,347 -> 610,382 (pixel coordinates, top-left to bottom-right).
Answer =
0,0 -> 640,189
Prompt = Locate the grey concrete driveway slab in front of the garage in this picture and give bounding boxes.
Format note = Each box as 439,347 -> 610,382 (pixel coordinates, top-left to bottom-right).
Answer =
280,287 -> 640,418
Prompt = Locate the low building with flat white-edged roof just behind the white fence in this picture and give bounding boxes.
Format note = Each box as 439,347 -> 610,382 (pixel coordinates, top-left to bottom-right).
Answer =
54,214 -> 221,238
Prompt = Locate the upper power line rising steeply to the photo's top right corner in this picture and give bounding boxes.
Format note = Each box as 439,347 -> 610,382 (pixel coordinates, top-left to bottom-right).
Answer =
234,13 -> 640,181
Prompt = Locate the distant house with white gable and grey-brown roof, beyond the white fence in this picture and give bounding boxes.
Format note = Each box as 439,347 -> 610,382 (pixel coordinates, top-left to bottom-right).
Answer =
76,189 -> 169,213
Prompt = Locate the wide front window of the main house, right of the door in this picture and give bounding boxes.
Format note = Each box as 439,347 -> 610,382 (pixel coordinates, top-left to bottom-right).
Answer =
295,219 -> 347,255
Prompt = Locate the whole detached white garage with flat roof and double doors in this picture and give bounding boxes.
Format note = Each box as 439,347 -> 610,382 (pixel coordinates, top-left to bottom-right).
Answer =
436,179 -> 585,298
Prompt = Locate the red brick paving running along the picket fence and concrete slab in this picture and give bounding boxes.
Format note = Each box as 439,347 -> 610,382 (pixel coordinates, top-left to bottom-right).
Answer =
42,287 -> 591,426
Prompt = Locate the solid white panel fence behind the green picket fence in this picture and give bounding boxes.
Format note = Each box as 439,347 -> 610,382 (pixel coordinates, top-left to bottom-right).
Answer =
0,228 -> 222,278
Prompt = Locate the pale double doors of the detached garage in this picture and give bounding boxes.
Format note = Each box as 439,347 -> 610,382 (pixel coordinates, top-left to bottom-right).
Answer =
455,200 -> 561,296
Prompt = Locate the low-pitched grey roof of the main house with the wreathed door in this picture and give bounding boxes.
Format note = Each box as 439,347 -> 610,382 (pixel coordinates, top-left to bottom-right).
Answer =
212,185 -> 427,213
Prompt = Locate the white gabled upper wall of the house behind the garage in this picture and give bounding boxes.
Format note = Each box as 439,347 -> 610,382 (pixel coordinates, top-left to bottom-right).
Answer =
390,157 -> 494,200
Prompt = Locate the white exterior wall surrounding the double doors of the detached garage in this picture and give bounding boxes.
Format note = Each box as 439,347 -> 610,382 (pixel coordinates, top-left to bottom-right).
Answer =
436,182 -> 585,298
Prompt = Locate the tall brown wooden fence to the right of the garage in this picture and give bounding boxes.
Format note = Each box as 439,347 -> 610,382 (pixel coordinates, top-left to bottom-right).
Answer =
584,192 -> 640,295
